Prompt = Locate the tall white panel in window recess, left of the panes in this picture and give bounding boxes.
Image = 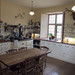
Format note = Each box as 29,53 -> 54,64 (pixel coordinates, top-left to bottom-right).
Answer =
40,14 -> 48,38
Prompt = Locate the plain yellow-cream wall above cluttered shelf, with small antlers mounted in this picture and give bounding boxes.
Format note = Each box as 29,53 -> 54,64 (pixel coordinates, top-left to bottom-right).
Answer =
1,0 -> 32,25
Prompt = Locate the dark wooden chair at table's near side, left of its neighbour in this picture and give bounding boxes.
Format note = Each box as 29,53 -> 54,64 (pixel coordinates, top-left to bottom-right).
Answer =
23,57 -> 35,75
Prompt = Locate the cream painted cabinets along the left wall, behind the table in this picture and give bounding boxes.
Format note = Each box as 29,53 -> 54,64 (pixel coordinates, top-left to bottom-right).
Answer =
0,40 -> 33,55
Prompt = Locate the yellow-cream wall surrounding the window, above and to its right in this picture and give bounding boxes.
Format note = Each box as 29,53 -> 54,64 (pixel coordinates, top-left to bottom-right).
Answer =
33,3 -> 75,38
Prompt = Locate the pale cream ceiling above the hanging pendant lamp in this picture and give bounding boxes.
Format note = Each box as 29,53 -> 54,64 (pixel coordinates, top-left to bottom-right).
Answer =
5,0 -> 75,8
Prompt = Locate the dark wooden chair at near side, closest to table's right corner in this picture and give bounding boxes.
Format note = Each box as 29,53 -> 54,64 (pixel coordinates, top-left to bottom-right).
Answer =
35,54 -> 45,75
